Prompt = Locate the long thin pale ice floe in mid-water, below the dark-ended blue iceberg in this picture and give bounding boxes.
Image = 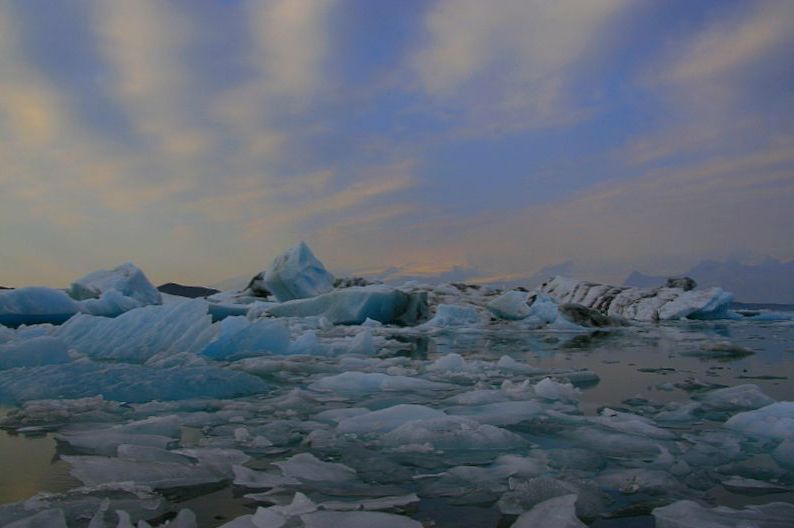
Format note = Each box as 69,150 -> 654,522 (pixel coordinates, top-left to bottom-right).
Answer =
309,372 -> 448,394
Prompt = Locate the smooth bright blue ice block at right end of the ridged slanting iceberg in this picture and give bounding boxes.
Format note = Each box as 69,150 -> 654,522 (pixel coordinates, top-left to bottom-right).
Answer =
201,316 -> 289,360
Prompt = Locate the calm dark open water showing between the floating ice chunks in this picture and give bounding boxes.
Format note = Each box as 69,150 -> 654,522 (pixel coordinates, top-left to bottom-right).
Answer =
0,308 -> 794,527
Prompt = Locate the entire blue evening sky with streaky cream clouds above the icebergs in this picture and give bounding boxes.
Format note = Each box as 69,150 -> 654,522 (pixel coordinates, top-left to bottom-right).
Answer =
0,0 -> 794,286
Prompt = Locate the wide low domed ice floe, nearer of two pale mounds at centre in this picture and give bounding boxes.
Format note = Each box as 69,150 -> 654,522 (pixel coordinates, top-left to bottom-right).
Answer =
381,416 -> 527,450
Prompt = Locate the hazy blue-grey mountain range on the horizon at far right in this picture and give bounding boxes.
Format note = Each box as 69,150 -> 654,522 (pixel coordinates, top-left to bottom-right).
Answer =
624,259 -> 794,304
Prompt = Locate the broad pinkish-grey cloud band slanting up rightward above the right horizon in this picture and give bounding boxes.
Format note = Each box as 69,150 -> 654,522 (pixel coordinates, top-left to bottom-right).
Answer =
457,136 -> 794,281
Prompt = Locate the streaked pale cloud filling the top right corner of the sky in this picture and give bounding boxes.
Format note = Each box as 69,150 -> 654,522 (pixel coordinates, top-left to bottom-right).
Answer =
617,0 -> 794,165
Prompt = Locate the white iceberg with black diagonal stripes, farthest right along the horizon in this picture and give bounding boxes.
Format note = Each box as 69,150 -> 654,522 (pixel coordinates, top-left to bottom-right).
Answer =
538,276 -> 734,322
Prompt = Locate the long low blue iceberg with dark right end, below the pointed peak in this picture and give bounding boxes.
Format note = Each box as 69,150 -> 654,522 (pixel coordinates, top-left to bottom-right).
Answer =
267,285 -> 427,325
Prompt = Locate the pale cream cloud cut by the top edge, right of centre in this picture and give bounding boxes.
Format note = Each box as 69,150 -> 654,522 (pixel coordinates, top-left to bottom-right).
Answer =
414,0 -> 627,133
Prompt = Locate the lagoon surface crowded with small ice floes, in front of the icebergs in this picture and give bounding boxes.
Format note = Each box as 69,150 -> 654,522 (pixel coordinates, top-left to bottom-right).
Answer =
0,302 -> 794,527
